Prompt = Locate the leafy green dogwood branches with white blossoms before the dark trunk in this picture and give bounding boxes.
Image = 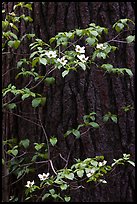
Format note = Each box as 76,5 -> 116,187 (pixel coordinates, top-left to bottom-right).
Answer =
2,2 -> 135,202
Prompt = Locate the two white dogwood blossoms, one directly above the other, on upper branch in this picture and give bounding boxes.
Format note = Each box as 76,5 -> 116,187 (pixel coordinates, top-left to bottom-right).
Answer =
75,45 -> 89,63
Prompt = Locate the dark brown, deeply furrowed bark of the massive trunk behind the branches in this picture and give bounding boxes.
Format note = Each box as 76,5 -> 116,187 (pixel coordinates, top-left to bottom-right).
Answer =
3,2 -> 135,202
